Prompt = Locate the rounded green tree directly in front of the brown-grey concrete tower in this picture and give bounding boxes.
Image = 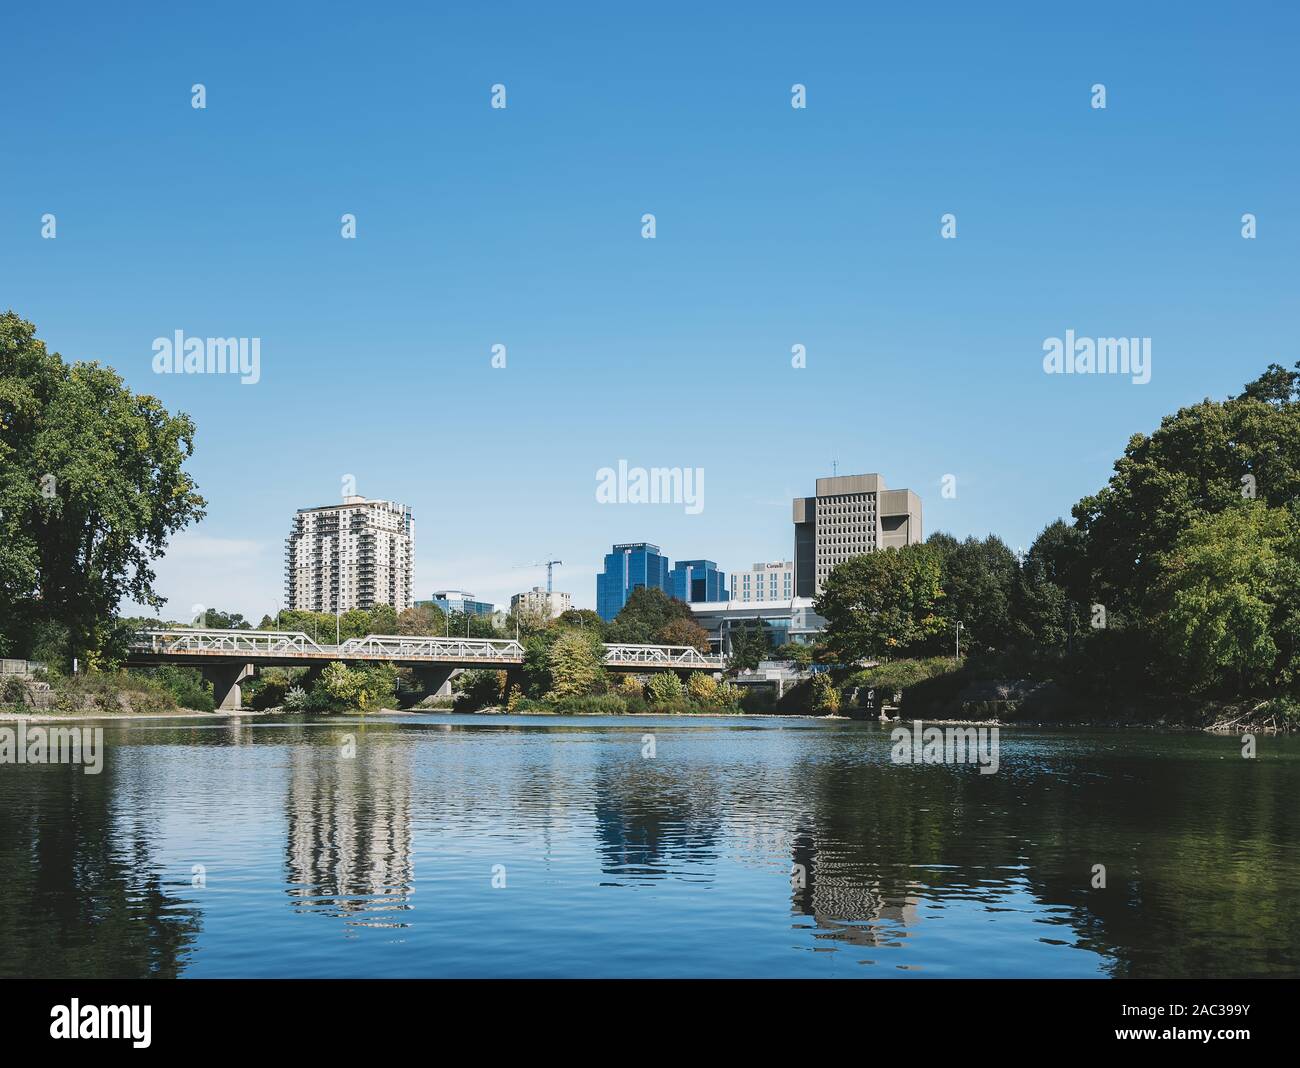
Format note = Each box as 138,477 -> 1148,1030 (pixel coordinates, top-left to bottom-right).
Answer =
814,544 -> 948,664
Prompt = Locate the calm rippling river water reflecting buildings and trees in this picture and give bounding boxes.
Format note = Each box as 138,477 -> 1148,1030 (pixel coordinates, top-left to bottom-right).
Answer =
0,715 -> 1300,977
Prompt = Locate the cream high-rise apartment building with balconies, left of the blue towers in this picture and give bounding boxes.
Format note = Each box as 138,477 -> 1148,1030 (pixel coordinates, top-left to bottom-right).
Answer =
285,496 -> 415,612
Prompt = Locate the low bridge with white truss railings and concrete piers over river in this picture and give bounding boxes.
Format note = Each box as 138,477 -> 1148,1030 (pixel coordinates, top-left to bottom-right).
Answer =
126,628 -> 727,709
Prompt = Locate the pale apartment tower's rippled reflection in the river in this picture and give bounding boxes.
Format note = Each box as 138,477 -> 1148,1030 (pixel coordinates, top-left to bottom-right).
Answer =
286,728 -> 415,928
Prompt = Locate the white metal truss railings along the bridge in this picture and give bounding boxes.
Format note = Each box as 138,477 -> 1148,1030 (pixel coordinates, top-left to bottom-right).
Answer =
131,628 -> 727,670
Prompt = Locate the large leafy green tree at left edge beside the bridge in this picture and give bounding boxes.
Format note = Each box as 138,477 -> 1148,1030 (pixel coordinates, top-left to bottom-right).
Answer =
0,312 -> 204,663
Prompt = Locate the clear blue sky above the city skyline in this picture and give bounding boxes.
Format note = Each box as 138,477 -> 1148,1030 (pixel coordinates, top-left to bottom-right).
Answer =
0,3 -> 1300,617
